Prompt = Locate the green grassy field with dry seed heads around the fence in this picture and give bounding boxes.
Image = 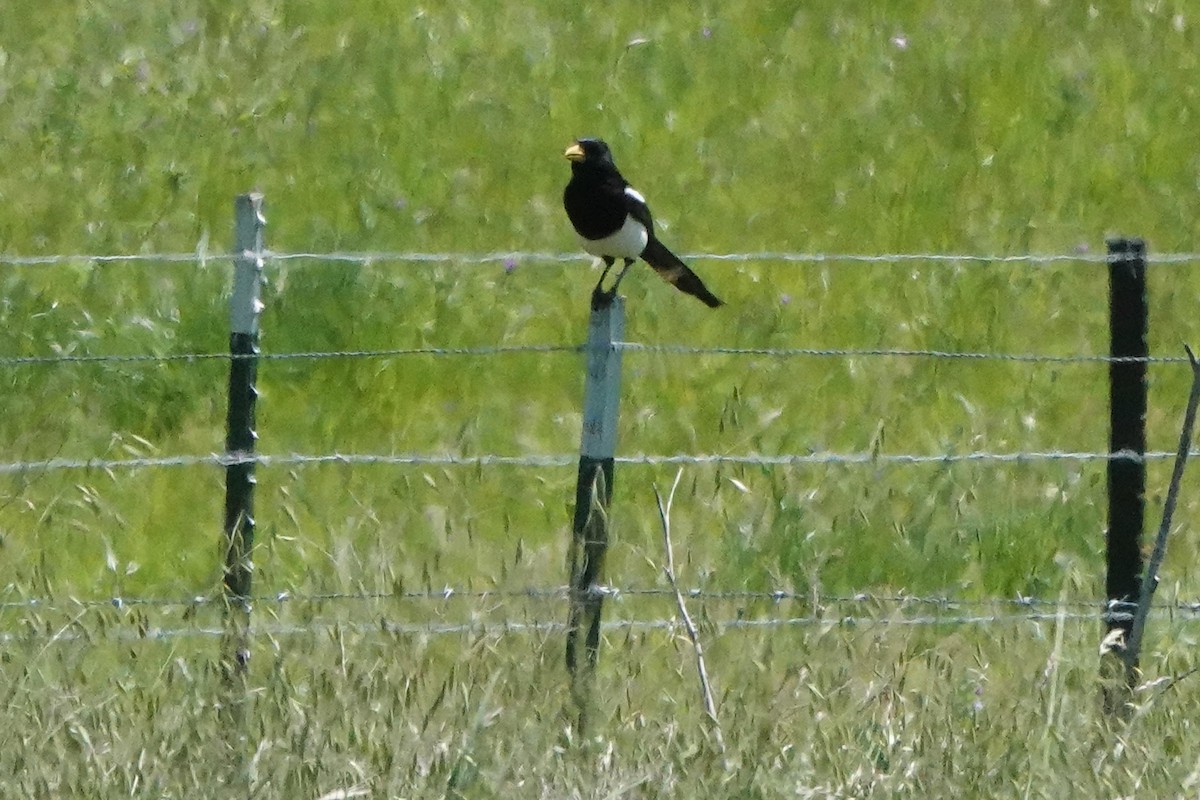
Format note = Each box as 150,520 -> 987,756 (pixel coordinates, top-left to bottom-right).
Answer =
0,0 -> 1200,798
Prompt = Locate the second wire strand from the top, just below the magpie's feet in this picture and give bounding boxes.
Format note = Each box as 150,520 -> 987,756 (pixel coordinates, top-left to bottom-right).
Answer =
0,342 -> 1188,367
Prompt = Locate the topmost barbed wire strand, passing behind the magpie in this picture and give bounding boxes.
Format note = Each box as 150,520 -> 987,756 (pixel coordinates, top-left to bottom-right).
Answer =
0,251 -> 1200,266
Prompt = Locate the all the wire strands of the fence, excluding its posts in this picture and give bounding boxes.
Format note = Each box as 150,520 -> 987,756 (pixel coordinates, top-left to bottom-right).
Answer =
0,251 -> 1200,642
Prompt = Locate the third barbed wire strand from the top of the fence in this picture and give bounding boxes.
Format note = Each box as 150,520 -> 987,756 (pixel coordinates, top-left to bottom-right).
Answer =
0,450 -> 1185,475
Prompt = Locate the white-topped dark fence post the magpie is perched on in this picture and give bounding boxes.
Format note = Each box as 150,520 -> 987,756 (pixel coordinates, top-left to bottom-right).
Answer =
566,297 -> 625,734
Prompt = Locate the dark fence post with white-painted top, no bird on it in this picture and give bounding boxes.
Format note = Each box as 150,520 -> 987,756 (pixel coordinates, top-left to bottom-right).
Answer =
223,192 -> 266,674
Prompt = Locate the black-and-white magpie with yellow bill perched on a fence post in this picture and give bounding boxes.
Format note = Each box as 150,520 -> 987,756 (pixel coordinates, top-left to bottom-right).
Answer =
563,139 -> 724,308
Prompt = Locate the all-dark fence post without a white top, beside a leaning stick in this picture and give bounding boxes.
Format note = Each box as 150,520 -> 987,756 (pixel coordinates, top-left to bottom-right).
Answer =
1104,239 -> 1150,711
